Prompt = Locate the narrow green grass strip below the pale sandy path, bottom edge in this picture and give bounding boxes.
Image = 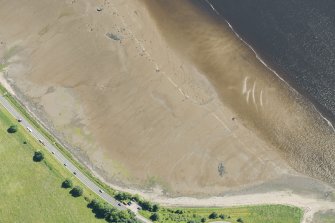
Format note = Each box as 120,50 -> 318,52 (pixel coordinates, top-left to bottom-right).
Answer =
141,205 -> 303,223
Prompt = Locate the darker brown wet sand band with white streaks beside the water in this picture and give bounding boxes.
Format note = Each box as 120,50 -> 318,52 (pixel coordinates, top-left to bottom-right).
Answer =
147,1 -> 335,184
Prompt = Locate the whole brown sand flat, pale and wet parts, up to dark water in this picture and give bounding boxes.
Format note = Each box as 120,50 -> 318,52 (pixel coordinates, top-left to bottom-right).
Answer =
0,0 -> 334,195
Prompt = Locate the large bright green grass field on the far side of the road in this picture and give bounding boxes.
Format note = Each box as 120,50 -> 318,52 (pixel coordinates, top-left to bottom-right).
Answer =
0,102 -> 104,222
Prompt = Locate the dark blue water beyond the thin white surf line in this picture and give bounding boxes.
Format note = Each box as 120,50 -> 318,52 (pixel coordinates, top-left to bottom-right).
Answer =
197,0 -> 335,123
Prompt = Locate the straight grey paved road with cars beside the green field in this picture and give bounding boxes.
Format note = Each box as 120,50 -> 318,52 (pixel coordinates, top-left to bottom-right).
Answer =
0,96 -> 135,213
